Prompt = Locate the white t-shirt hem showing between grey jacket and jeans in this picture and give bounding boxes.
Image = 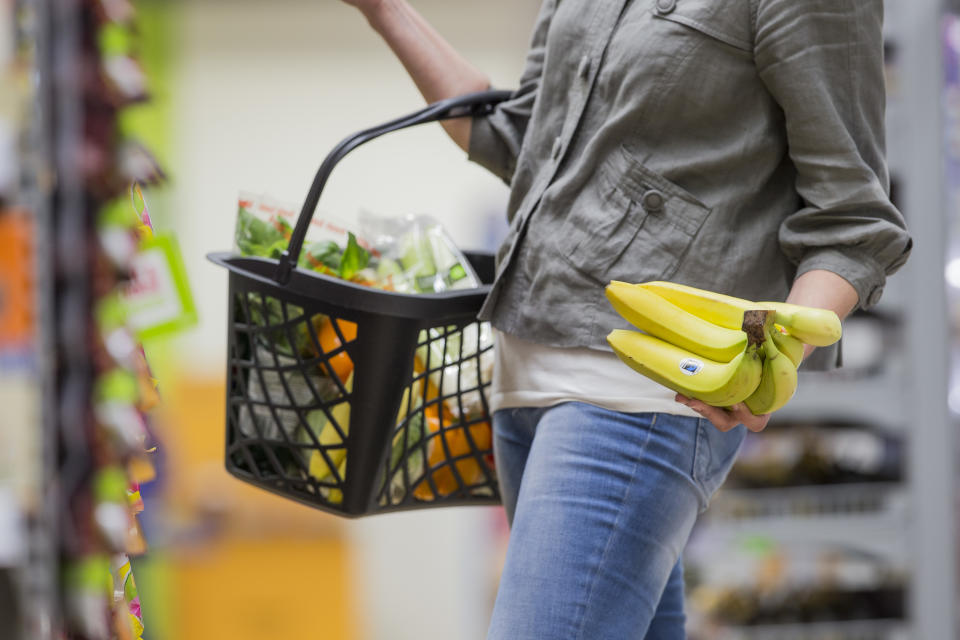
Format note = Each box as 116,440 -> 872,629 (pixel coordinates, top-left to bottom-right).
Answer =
490,331 -> 700,418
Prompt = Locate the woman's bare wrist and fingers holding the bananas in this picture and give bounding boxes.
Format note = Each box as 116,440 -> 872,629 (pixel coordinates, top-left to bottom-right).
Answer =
676,269 -> 857,431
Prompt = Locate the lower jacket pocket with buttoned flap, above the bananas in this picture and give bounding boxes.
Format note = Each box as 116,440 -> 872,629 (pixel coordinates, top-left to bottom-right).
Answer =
557,145 -> 710,283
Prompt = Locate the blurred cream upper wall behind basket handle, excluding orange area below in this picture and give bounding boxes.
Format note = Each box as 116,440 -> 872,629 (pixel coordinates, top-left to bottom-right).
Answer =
173,0 -> 538,373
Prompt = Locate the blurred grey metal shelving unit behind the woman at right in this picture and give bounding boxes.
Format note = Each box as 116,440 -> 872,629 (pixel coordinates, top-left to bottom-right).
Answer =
687,0 -> 958,640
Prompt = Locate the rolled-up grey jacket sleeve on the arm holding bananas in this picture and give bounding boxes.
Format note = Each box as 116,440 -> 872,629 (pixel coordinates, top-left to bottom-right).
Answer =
755,0 -> 912,308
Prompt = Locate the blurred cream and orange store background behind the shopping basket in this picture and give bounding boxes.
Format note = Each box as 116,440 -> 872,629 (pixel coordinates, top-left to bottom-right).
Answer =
153,0 -> 539,640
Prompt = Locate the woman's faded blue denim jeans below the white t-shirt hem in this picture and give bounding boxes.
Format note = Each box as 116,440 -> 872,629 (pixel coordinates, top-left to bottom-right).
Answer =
487,402 -> 745,640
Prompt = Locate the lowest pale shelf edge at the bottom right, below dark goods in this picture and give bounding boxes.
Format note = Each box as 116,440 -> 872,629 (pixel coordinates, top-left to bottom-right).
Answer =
710,619 -> 912,640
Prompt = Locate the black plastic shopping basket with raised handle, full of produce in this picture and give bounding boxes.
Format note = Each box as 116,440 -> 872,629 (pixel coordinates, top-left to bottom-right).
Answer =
208,91 -> 510,517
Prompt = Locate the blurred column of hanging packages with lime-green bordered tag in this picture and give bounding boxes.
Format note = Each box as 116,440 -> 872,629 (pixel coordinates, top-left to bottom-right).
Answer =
38,0 -> 194,640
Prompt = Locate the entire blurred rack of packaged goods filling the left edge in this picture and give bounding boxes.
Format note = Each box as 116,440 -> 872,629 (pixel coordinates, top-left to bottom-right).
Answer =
0,0 -> 193,640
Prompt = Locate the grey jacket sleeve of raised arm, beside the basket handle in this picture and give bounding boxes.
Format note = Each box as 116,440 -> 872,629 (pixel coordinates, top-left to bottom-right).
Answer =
468,0 -> 557,184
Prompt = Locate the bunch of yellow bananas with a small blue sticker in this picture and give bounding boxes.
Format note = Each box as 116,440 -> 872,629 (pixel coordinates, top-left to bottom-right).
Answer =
606,281 -> 841,415
